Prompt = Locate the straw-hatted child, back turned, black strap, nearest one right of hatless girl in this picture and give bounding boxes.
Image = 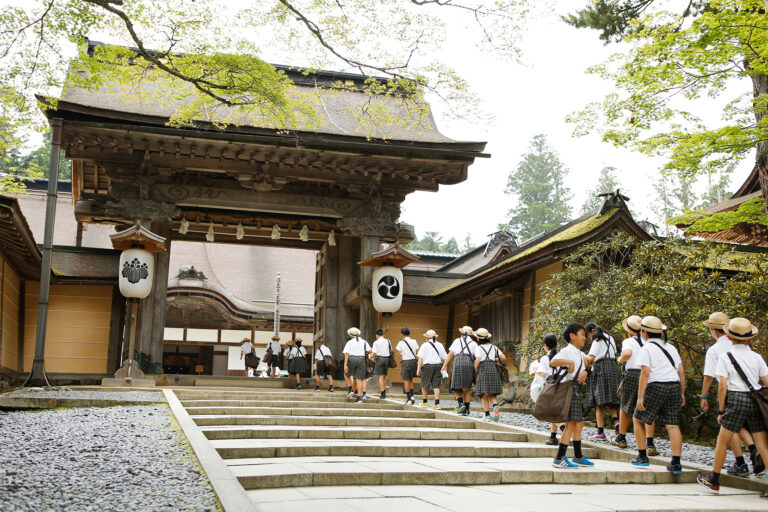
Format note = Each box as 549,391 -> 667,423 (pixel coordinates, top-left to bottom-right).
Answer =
630,316 -> 685,475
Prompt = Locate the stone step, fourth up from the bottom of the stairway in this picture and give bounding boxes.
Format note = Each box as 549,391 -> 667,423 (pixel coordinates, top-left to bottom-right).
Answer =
190,413 -> 481,429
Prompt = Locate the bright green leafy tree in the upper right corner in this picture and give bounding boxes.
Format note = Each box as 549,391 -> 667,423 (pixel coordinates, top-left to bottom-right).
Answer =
565,0 -> 768,228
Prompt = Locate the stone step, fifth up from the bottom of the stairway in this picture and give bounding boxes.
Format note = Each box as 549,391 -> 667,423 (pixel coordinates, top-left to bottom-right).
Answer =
186,404 -> 438,423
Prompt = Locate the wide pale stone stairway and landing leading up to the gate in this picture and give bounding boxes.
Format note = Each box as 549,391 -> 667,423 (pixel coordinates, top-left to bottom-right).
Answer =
166,388 -> 768,512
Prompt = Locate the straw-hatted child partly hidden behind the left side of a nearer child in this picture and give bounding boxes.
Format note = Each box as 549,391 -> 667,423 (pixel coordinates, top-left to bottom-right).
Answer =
611,315 -> 659,456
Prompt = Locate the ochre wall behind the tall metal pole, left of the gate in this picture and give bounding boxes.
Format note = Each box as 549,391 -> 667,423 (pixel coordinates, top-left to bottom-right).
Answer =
24,281 -> 113,374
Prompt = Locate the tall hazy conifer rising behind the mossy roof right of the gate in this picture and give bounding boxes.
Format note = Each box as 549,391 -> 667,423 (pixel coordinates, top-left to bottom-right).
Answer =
504,135 -> 571,240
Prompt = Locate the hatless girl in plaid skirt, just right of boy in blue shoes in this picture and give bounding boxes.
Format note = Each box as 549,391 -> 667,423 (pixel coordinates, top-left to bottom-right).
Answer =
585,322 -> 621,441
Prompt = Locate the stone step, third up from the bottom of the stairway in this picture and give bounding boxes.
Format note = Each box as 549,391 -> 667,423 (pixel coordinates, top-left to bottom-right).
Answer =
200,425 -> 528,446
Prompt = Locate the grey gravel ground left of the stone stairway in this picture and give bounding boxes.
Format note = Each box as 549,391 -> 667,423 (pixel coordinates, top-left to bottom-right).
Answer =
0,404 -> 220,512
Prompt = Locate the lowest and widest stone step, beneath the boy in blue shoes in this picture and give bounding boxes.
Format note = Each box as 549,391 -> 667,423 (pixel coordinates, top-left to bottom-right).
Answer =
225,457 -> 697,492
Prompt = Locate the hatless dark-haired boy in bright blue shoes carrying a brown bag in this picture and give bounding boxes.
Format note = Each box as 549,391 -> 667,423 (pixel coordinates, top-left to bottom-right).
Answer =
549,322 -> 595,468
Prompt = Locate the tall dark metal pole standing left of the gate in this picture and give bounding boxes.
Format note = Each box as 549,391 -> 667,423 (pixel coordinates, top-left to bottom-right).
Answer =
22,118 -> 62,386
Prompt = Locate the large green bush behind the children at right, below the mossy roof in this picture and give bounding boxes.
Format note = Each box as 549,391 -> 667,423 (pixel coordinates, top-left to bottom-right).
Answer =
522,236 -> 768,437
